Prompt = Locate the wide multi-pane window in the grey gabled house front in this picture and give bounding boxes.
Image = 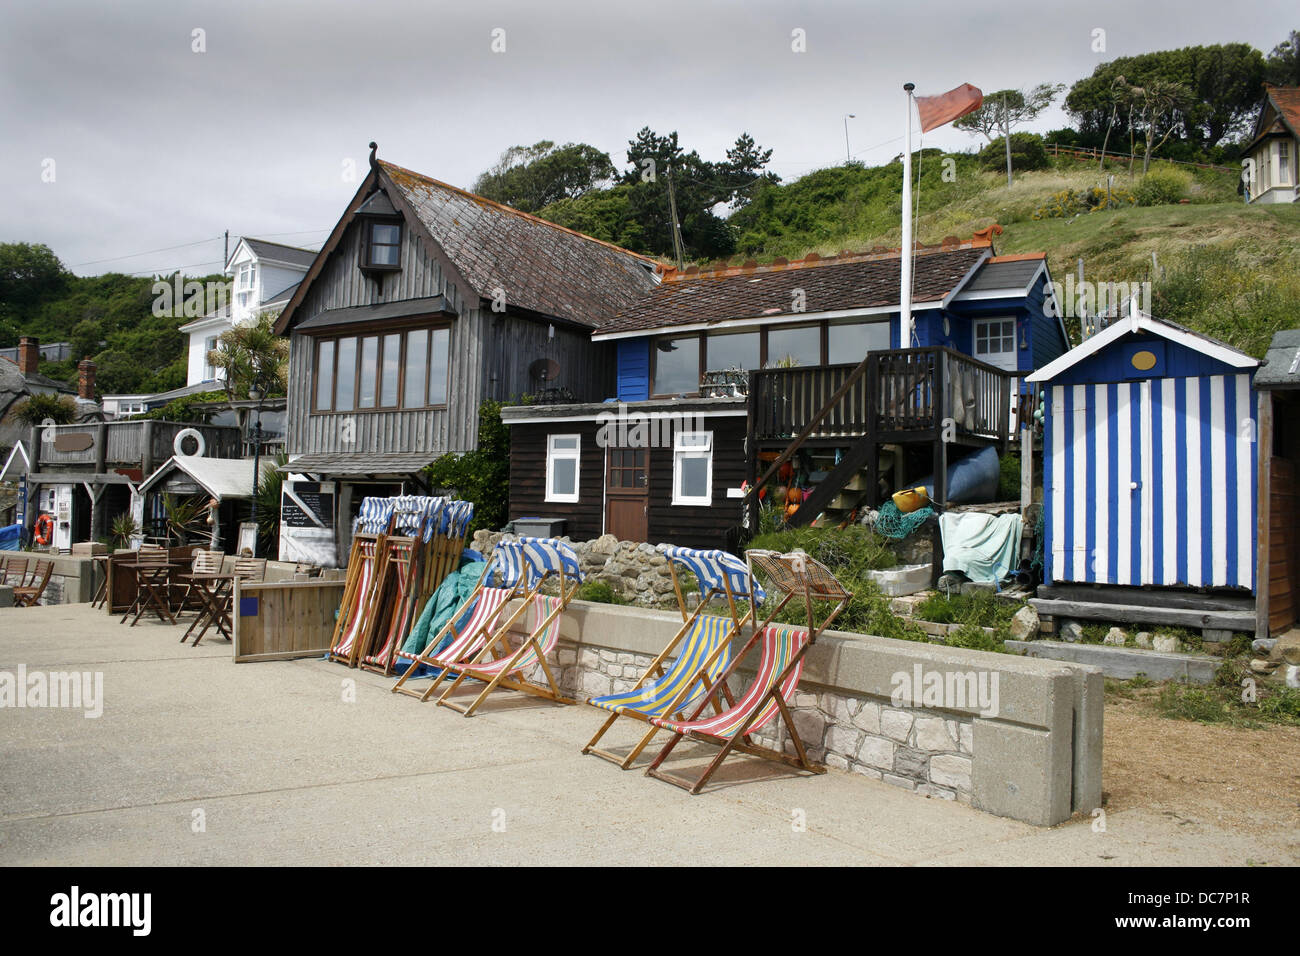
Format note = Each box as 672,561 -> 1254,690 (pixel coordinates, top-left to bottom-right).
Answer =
313,326 -> 451,411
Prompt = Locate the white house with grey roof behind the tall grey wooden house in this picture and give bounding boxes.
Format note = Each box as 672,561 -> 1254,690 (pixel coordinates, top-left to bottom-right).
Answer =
181,237 -> 316,385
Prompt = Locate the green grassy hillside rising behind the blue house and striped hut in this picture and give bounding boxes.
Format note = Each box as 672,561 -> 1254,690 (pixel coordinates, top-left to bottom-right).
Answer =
732,152 -> 1300,355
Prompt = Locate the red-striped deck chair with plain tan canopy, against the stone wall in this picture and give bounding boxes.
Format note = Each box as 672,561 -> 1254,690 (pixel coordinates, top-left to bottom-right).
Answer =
646,550 -> 853,793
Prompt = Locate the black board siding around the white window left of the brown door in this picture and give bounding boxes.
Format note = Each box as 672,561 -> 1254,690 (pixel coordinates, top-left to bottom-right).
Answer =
508,421 -> 605,541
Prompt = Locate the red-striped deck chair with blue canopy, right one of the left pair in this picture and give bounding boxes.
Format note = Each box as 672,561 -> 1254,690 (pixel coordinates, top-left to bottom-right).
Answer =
438,537 -> 582,717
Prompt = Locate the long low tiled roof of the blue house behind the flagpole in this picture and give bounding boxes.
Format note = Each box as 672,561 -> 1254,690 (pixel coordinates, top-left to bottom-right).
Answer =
593,241 -> 991,341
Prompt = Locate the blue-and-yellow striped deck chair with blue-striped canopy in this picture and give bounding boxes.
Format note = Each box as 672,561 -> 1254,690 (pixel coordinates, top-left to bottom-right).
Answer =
582,545 -> 766,770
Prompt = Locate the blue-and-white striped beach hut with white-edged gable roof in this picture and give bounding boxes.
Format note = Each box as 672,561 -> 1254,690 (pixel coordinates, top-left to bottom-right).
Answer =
1028,311 -> 1260,592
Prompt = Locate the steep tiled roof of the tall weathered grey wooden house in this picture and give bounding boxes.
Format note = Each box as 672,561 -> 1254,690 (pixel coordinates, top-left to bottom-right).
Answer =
380,161 -> 654,328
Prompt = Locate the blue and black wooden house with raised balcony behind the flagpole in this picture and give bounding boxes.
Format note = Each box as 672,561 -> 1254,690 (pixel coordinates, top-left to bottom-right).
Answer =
503,233 -> 1069,546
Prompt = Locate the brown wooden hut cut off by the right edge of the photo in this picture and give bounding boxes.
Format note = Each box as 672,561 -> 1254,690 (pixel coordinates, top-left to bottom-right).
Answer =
1255,329 -> 1300,637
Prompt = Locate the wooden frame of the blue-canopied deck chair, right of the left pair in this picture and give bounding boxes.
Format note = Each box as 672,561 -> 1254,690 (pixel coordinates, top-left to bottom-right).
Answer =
438,537 -> 582,717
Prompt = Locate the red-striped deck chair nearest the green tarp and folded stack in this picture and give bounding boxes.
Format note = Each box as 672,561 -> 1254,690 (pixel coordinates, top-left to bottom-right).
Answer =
393,541 -> 541,701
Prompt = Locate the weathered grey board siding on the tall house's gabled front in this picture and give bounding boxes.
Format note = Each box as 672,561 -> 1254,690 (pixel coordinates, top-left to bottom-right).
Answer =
286,214 -> 484,455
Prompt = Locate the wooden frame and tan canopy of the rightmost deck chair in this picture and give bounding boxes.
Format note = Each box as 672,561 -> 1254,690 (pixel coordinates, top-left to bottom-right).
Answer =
646,550 -> 853,795
